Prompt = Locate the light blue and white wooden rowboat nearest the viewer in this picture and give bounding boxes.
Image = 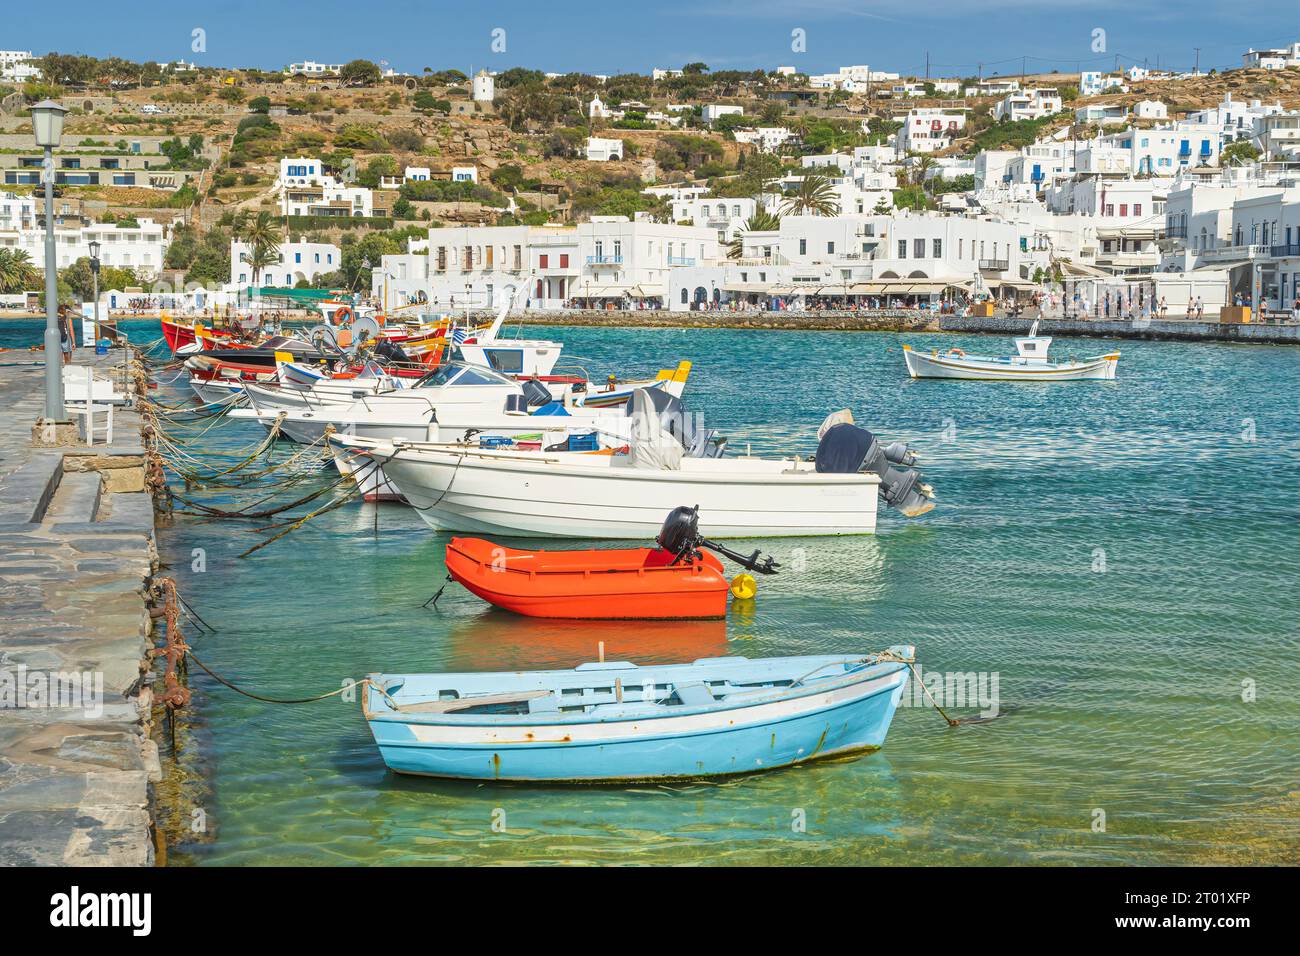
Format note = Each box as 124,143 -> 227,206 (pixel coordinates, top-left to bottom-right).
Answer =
361,646 -> 915,783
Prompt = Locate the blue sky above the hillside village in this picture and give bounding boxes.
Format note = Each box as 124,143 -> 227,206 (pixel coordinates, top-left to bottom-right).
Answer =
10,0 -> 1300,77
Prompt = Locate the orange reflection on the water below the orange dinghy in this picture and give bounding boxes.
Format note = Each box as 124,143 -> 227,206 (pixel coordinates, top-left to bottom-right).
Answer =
447,609 -> 728,671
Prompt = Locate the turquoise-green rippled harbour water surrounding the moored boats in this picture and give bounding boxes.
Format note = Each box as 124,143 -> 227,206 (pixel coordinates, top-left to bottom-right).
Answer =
0,321 -> 1300,864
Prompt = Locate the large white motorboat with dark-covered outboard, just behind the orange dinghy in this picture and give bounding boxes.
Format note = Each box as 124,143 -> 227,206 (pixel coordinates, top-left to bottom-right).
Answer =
329,402 -> 933,538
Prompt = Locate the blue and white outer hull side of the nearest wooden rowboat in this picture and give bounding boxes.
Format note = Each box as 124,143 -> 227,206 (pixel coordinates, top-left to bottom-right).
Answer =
363,665 -> 907,783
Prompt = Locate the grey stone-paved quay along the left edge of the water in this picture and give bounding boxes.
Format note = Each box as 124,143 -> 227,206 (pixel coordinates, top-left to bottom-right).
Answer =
0,350 -> 160,866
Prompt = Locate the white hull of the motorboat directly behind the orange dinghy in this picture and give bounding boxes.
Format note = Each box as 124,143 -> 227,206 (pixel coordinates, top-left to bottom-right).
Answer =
381,451 -> 879,540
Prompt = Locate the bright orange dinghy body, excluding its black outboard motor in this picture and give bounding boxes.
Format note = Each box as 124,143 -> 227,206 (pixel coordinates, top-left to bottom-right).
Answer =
447,537 -> 728,619
